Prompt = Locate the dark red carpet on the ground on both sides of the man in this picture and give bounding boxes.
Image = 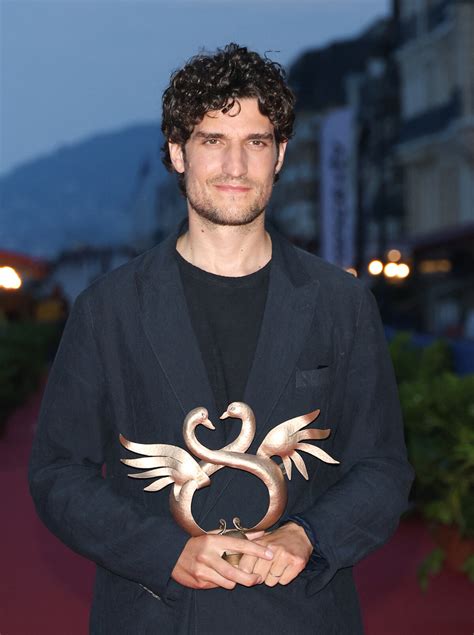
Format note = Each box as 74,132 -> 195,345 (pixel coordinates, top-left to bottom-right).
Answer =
0,386 -> 474,635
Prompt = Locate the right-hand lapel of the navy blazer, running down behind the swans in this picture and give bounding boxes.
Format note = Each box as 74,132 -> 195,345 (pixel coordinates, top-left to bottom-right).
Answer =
201,231 -> 319,520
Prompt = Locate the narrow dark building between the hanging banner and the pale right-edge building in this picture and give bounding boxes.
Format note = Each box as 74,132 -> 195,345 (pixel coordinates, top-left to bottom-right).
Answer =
346,10 -> 405,275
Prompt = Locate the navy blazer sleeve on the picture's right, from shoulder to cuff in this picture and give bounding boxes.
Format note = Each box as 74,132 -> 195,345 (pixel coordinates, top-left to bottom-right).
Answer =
298,290 -> 413,594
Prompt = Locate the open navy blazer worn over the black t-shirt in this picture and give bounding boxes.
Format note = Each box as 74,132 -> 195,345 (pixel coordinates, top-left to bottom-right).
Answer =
30,226 -> 412,635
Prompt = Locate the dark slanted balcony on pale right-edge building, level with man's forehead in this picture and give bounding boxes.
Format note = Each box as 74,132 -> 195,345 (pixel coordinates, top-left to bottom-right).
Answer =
399,90 -> 461,143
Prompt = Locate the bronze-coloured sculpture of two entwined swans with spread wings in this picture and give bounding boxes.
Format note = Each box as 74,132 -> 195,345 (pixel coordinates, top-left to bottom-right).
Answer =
120,401 -> 339,536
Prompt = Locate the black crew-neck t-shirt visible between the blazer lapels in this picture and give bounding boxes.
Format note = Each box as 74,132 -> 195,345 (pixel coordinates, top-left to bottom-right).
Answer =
176,252 -> 271,414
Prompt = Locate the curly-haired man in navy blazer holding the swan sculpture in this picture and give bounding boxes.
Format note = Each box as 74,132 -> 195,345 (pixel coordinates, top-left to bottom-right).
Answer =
30,44 -> 412,635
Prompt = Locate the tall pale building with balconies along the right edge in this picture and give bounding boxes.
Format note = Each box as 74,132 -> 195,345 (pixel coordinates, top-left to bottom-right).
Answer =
396,0 -> 474,336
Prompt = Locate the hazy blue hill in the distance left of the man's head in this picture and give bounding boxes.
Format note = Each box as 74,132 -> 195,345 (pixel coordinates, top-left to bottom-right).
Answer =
0,123 -> 169,258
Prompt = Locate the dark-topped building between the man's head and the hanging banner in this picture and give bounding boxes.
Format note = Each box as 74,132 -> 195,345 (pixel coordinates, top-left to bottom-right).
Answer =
270,20 -> 385,253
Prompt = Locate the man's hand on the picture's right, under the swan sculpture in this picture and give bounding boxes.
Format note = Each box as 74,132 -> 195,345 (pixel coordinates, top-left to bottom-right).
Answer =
239,522 -> 313,586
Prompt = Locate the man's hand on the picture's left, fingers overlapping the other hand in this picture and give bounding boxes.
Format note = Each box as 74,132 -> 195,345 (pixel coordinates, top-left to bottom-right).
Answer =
171,531 -> 273,589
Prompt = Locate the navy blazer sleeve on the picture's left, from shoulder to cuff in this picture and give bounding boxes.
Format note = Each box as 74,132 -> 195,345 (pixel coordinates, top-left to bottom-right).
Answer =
29,295 -> 189,596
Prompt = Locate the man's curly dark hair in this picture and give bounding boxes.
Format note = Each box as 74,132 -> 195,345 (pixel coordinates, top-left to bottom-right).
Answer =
161,43 -> 295,193
